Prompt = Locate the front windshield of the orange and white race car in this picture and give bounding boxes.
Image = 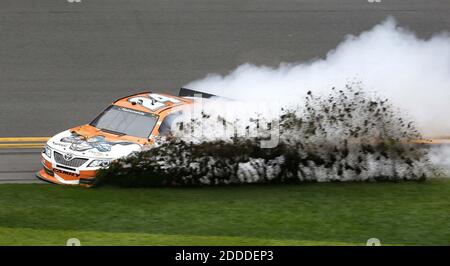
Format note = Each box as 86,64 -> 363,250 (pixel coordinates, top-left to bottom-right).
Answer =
90,105 -> 158,138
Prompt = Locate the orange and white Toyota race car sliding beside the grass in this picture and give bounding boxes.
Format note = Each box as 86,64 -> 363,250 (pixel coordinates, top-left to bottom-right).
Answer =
36,88 -> 215,186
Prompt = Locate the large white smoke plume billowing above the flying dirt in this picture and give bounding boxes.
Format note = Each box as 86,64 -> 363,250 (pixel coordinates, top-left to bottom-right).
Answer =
186,18 -> 450,137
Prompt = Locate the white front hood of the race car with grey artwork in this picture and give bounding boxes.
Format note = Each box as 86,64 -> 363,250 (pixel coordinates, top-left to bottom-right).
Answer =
47,130 -> 142,159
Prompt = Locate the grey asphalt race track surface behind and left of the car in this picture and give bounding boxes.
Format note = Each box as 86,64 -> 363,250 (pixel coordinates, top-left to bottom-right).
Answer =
0,0 -> 450,182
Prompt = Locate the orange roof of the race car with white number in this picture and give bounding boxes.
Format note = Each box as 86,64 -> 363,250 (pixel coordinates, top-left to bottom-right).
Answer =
113,91 -> 193,114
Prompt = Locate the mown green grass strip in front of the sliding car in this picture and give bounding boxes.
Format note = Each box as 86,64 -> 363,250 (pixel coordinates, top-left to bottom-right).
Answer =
0,179 -> 450,245
